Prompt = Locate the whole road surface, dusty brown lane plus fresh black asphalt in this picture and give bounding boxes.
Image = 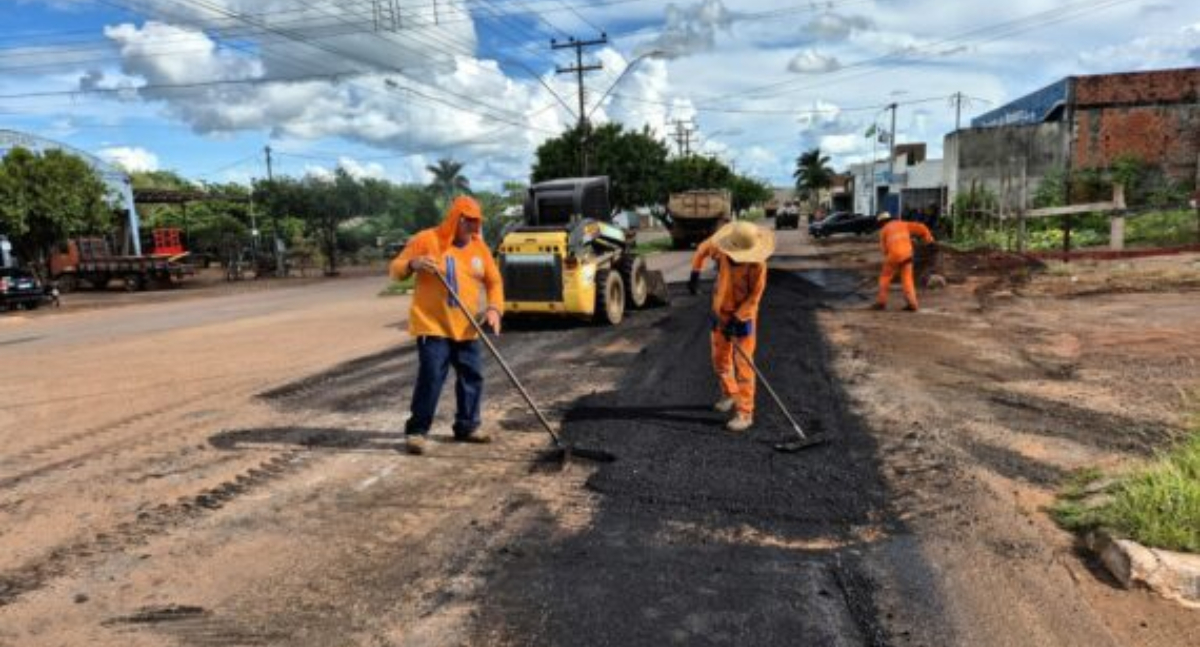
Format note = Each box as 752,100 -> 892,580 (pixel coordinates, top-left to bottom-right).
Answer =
7,225 -> 1180,647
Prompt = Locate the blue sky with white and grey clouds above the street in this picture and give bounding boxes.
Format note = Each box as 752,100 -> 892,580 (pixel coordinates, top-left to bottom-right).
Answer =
0,0 -> 1200,187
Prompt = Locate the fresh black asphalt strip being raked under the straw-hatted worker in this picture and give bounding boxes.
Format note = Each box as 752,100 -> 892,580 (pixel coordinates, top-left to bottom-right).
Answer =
473,271 -> 954,646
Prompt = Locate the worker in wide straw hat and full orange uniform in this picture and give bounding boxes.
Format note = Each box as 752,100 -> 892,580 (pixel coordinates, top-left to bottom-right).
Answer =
689,221 -> 775,433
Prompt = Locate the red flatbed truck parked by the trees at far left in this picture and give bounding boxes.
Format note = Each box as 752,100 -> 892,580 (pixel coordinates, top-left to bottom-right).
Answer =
49,228 -> 196,292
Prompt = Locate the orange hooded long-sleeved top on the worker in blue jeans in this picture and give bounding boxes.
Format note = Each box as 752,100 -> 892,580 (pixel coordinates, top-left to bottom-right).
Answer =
389,197 -> 504,341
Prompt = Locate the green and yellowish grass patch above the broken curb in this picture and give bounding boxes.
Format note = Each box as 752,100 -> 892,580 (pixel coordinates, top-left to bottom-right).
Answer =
1050,431 -> 1200,552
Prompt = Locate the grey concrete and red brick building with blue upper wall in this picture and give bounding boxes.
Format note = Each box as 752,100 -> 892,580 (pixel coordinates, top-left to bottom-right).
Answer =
944,67 -> 1200,210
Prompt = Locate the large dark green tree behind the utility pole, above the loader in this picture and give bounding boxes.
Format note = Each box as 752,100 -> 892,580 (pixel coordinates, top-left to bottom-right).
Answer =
532,124 -> 668,209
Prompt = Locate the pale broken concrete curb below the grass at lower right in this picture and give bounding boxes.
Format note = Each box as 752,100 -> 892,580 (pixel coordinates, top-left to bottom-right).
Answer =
1085,532 -> 1200,609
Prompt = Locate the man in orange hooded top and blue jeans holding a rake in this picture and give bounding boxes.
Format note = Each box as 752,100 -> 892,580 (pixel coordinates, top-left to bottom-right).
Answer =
390,196 -> 504,454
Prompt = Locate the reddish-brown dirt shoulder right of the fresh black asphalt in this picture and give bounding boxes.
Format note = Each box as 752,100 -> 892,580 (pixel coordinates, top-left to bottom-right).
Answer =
814,232 -> 1200,645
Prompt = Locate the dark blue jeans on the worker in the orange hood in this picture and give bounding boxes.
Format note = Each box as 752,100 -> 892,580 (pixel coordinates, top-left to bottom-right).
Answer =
404,337 -> 484,438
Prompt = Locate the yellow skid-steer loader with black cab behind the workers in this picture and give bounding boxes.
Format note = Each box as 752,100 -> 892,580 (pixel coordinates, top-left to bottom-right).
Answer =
497,176 -> 667,325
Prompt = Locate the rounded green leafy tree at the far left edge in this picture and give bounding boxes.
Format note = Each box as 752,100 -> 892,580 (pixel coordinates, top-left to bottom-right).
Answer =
0,148 -> 114,276
